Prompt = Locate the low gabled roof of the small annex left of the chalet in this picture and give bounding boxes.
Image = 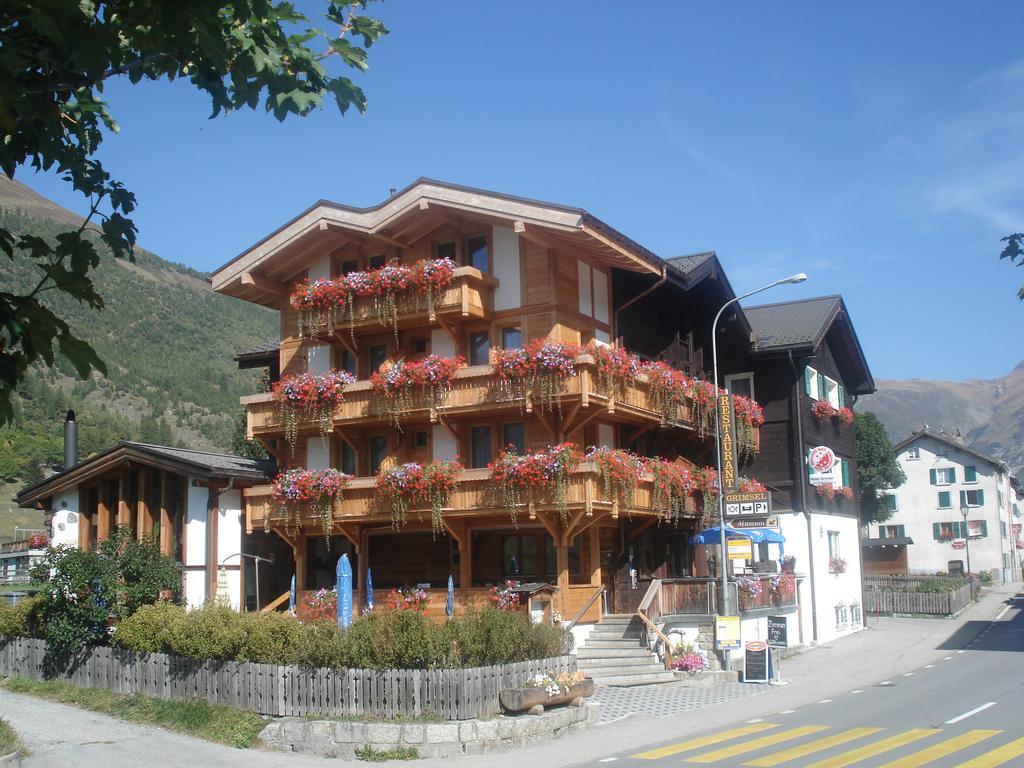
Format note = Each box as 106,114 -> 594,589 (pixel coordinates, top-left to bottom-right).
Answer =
17,441 -> 275,506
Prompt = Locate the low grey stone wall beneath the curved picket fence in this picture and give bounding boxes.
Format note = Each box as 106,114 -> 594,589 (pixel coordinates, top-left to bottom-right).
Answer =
259,701 -> 601,760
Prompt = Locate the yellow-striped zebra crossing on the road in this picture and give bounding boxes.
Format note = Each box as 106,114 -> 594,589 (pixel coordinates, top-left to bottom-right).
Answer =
630,723 -> 1024,768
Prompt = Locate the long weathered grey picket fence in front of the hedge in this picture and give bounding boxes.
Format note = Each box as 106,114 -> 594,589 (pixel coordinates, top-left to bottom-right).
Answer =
0,637 -> 575,720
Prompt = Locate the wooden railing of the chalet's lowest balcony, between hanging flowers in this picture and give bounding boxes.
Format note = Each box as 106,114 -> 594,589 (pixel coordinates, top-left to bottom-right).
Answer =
245,462 -> 696,535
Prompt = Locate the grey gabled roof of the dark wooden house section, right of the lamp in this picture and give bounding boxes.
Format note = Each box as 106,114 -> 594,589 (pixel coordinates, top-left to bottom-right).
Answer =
744,295 -> 874,394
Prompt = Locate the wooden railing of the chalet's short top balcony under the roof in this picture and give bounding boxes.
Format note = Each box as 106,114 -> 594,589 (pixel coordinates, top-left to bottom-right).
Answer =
284,266 -> 498,338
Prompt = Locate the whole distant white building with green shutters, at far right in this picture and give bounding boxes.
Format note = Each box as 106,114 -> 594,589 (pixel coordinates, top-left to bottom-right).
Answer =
866,427 -> 1024,582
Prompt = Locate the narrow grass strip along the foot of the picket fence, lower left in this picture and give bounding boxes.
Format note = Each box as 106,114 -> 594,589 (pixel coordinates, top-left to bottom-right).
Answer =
3,677 -> 266,749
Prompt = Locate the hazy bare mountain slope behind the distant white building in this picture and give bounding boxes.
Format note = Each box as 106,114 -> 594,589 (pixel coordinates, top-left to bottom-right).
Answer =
857,361 -> 1024,474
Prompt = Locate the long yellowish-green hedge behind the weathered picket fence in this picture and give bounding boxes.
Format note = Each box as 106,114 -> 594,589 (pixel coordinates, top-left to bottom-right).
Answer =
112,603 -> 571,669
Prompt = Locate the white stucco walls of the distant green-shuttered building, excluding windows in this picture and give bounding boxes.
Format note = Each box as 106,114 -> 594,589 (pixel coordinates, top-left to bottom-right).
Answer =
868,434 -> 1020,581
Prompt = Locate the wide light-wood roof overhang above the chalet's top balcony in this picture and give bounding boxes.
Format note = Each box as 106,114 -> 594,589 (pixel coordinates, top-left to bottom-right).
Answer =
210,179 -> 664,307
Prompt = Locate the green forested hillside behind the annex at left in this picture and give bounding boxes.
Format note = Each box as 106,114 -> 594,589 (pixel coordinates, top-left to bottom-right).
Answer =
0,175 -> 276,482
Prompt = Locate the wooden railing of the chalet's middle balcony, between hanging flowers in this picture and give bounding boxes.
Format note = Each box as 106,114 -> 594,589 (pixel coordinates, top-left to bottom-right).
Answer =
242,354 -> 760,450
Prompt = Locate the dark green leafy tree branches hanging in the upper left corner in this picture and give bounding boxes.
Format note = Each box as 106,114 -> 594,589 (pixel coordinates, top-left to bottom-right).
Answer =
0,0 -> 387,424
